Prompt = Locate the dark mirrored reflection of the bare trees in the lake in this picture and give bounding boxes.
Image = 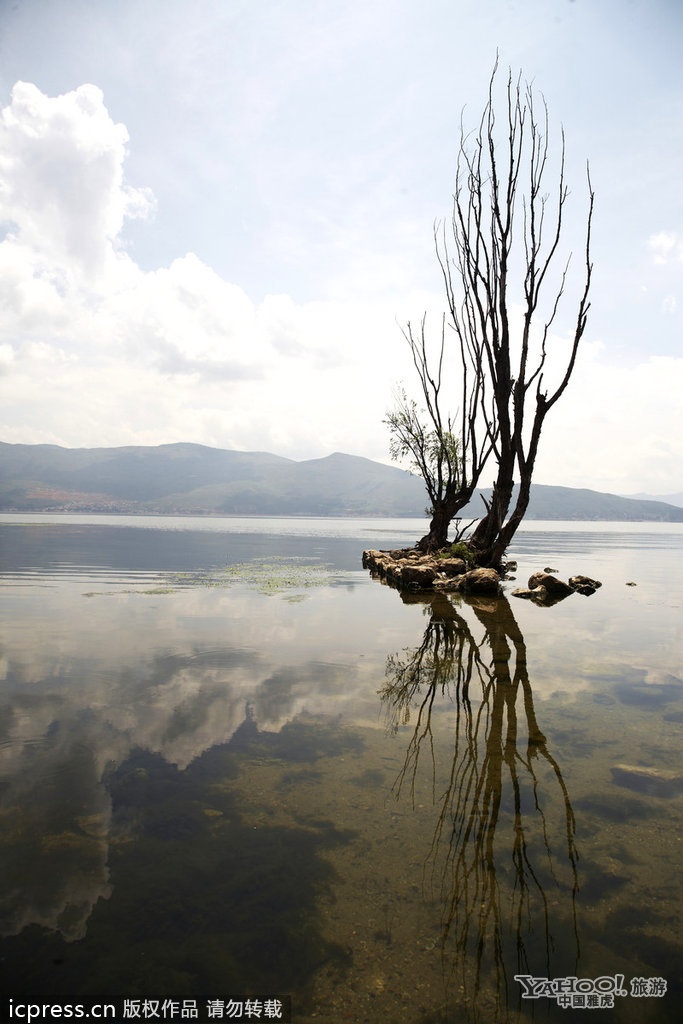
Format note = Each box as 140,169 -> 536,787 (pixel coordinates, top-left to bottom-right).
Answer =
381,594 -> 579,1020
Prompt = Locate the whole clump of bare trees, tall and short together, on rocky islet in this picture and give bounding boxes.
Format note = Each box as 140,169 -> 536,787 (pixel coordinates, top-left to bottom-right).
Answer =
393,61 -> 594,565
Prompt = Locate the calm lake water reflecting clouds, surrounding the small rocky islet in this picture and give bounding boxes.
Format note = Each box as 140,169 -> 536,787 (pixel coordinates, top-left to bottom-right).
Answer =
0,515 -> 683,1024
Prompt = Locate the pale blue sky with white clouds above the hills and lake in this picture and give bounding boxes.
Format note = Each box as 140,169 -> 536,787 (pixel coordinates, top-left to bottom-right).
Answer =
0,0 -> 683,495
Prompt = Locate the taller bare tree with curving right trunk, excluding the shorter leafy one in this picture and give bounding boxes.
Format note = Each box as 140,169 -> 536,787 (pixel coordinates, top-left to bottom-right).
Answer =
458,66 -> 594,565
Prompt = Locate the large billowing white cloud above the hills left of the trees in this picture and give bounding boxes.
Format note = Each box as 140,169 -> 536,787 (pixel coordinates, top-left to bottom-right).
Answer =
0,83 -> 421,457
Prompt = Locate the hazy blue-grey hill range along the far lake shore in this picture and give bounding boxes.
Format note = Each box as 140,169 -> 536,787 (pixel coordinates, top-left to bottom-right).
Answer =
0,442 -> 683,522
